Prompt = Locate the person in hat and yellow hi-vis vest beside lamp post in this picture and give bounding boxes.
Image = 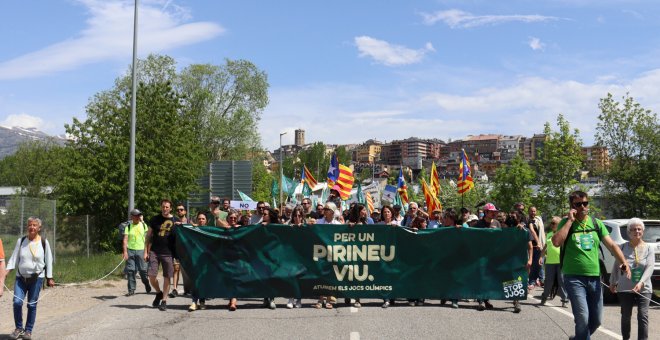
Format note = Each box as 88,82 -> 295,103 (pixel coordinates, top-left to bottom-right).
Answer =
122,209 -> 151,296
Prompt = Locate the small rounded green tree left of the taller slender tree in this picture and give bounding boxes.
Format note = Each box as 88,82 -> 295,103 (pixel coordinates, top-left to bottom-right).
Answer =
491,154 -> 535,209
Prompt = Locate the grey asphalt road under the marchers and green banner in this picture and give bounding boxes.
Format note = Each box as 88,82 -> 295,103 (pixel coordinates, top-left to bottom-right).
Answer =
23,291 -> 660,340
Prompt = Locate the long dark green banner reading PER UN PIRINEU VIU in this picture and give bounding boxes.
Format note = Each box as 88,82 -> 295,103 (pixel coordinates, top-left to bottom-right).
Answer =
175,225 -> 528,300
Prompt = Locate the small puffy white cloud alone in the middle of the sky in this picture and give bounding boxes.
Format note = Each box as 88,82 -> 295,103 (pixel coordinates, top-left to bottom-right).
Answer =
355,35 -> 435,66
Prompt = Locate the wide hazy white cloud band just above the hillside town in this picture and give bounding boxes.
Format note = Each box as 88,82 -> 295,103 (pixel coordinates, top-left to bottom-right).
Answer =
260,69 -> 660,150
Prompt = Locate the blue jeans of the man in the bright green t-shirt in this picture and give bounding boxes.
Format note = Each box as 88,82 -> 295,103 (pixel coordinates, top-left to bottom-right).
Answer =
564,275 -> 603,340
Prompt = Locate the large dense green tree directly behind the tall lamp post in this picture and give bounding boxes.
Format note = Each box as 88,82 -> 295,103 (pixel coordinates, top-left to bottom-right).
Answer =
58,78 -> 205,248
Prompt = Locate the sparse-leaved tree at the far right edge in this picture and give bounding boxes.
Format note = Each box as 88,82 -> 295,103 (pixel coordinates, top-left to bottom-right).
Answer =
596,93 -> 660,217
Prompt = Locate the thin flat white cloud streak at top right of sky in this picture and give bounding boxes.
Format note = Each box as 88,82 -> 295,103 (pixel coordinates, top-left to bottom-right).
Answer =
421,9 -> 559,28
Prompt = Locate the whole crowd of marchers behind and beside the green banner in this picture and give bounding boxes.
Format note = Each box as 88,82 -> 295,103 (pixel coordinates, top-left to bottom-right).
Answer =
0,191 -> 655,339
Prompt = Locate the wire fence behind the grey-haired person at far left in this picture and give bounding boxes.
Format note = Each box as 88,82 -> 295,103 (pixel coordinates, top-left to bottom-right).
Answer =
0,196 -> 103,261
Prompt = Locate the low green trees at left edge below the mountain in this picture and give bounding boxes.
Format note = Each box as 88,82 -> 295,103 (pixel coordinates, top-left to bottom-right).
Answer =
0,140 -> 67,198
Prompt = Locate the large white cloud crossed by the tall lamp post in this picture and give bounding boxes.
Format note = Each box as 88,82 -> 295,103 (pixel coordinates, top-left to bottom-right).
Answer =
0,0 -> 224,80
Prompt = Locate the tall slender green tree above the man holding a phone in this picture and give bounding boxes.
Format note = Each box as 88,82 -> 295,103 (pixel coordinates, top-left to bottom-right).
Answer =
535,114 -> 583,216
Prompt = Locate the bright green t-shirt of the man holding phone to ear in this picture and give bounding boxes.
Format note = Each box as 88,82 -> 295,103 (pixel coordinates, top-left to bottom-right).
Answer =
557,217 -> 610,276
